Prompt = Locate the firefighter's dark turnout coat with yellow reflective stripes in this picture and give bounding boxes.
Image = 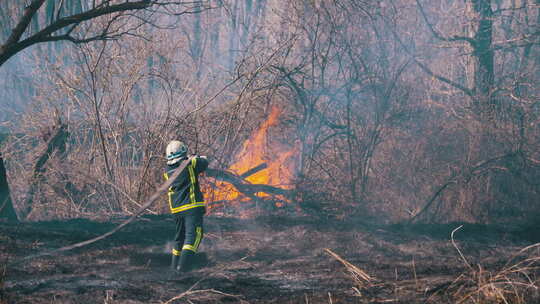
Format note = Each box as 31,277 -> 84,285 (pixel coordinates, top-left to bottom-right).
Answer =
163,156 -> 208,213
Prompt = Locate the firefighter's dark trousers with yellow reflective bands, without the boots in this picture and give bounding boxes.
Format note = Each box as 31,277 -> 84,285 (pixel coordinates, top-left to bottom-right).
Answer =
174,212 -> 204,252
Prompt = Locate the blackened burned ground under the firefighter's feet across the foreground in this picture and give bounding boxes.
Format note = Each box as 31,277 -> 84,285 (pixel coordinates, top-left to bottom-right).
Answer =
0,216 -> 540,303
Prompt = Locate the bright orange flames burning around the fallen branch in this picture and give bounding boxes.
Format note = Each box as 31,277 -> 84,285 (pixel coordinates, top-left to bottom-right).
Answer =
208,107 -> 298,206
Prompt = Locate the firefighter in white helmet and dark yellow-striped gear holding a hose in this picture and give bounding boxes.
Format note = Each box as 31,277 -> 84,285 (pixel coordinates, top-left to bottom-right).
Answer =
163,140 -> 208,272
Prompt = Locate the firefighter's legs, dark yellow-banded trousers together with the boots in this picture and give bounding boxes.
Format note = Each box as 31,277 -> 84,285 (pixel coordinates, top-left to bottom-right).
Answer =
172,208 -> 204,271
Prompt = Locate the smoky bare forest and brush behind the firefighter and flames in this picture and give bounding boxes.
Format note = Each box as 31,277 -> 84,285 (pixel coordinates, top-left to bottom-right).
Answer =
0,0 -> 540,223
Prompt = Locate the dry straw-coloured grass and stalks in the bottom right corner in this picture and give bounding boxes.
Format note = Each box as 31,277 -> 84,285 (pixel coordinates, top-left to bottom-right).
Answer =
325,227 -> 540,304
